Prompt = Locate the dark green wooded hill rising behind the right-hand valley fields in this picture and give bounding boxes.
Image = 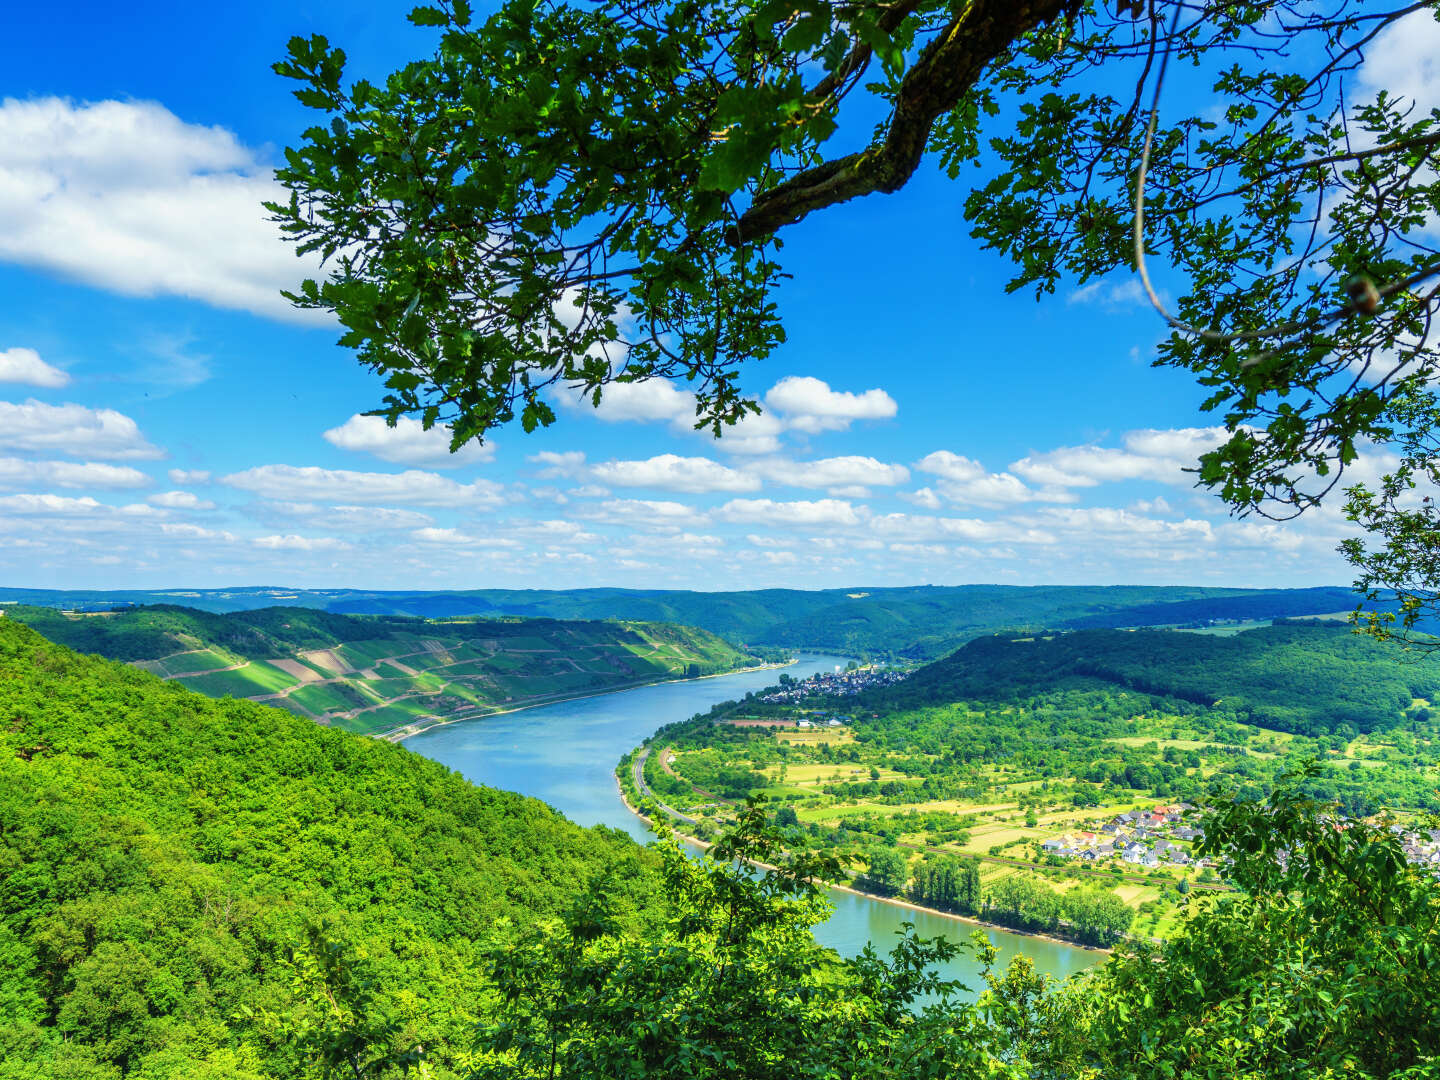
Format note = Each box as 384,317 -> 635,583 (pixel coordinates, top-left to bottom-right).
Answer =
870,622 -> 1440,734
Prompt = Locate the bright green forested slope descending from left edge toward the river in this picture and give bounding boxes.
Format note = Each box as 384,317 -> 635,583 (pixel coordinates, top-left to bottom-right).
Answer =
0,618 -> 651,1080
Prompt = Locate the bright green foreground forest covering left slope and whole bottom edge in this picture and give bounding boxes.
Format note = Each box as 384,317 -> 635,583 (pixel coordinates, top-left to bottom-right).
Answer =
0,619 -> 1440,1080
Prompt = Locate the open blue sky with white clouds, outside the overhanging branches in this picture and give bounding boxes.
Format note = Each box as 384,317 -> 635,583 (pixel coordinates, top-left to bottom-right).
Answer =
0,0 -> 1440,589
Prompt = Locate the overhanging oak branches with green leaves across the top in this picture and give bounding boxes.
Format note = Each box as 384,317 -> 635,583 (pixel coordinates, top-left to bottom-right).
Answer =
271,0 -> 1440,616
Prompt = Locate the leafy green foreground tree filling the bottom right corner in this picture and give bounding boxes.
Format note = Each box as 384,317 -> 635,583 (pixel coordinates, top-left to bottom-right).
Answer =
1041,771 -> 1440,1080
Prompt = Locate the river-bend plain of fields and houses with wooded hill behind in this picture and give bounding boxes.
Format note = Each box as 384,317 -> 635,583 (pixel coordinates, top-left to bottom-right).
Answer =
627,625 -> 1440,937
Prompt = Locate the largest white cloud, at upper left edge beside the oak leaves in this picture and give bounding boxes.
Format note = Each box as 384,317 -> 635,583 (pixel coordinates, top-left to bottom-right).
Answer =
0,98 -> 320,323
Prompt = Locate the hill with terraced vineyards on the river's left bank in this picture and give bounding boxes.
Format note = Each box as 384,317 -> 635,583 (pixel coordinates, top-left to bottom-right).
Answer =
3,605 -> 752,733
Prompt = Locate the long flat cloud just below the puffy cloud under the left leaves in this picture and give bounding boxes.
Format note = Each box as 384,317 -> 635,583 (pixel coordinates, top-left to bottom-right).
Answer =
220,465 -> 504,507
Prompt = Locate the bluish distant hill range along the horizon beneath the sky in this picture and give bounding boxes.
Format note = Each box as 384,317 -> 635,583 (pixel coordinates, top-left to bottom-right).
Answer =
0,585 -> 1393,660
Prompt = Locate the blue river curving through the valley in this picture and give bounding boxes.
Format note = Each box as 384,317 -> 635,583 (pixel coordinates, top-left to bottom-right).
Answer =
405,654 -> 1100,991
